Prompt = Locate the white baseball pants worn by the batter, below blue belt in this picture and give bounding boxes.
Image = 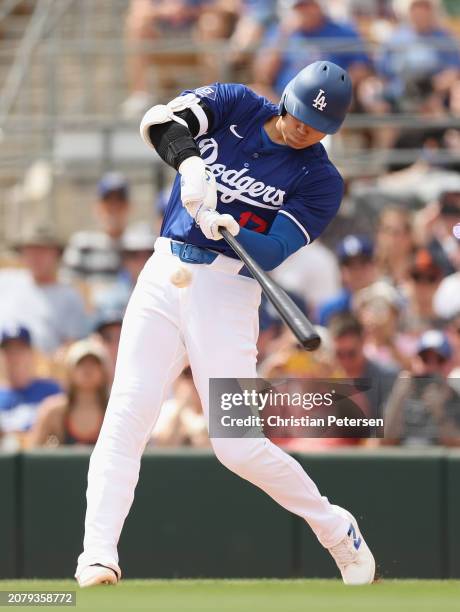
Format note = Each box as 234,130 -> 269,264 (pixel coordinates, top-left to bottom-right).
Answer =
77,238 -> 348,574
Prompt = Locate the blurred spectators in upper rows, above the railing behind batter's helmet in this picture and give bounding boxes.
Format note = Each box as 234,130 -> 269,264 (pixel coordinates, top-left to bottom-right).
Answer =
121,0 -> 460,165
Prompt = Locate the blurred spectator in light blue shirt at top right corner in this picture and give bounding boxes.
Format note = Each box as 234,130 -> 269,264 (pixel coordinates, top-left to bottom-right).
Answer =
377,0 -> 460,111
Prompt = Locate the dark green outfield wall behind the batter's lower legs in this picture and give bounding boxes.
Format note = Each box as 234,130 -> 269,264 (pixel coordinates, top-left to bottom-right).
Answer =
0,449 -> 460,578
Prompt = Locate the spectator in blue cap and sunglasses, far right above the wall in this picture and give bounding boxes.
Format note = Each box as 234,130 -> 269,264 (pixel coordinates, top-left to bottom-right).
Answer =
383,330 -> 460,446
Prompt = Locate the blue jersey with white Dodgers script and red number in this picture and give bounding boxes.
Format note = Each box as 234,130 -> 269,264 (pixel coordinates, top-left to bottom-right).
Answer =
161,83 -> 343,257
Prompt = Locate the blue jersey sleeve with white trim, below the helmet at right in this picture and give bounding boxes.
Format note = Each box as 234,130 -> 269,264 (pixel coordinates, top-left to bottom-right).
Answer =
278,166 -> 344,244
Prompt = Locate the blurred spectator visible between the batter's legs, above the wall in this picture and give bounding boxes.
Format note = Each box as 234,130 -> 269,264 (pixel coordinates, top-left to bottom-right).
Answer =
151,367 -> 209,447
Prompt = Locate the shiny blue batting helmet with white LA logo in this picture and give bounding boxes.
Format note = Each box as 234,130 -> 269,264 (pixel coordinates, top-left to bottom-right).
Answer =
279,61 -> 352,134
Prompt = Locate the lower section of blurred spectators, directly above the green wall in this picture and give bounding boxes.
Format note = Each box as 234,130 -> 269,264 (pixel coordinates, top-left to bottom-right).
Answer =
0,167 -> 460,450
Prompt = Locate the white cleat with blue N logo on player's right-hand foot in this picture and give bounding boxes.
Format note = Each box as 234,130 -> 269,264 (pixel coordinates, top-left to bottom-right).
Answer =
329,506 -> 375,585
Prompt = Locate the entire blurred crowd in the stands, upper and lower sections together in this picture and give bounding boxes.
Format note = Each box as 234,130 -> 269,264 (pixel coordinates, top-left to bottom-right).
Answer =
0,0 -> 460,450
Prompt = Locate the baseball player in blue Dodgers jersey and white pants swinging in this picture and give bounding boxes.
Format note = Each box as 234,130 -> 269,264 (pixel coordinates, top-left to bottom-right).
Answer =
75,61 -> 375,587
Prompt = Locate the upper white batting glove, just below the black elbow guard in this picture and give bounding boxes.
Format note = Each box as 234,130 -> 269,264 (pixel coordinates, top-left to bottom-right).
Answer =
179,156 -> 217,219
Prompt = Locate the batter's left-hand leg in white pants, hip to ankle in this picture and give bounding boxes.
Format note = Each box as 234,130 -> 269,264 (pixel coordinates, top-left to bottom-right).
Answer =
76,254 -> 185,576
